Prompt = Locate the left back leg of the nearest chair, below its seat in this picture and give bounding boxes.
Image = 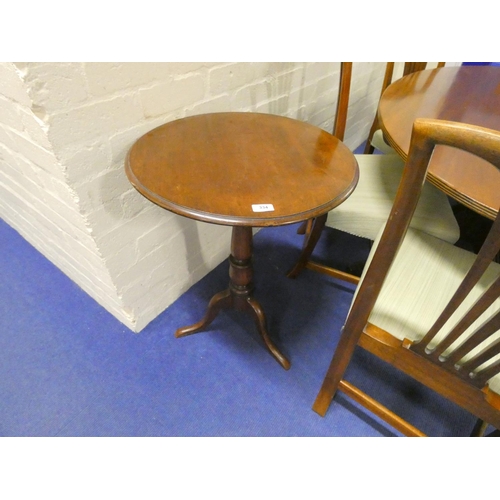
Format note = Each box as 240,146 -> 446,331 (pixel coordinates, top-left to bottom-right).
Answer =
312,323 -> 361,417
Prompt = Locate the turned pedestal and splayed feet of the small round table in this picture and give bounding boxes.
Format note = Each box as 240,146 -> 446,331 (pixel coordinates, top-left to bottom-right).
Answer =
175,226 -> 290,370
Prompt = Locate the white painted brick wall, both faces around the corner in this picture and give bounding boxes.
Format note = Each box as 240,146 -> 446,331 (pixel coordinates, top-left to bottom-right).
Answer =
0,62 -> 412,331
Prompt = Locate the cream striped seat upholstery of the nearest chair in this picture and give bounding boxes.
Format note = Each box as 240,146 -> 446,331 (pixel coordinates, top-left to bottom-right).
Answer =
358,229 -> 500,394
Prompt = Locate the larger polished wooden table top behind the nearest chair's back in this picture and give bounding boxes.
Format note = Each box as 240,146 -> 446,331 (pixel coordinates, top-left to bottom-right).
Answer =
378,66 -> 500,219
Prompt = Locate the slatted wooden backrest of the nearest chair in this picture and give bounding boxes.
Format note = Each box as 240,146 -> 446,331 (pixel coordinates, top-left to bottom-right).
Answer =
346,119 -> 500,398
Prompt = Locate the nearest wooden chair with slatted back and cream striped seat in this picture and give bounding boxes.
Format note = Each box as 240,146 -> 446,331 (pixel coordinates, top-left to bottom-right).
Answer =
313,119 -> 500,436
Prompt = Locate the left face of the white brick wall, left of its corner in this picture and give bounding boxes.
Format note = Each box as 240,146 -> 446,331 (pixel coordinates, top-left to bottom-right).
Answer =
0,63 -> 133,328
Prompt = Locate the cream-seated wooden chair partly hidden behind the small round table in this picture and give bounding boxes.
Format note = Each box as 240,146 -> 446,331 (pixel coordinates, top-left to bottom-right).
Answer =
288,63 -> 460,283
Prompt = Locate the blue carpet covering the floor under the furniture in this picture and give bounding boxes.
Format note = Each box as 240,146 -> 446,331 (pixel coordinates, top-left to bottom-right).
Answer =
0,220 -> 475,436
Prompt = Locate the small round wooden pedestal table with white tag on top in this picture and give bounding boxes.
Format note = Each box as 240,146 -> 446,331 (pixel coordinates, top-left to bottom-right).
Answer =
125,113 -> 359,369
